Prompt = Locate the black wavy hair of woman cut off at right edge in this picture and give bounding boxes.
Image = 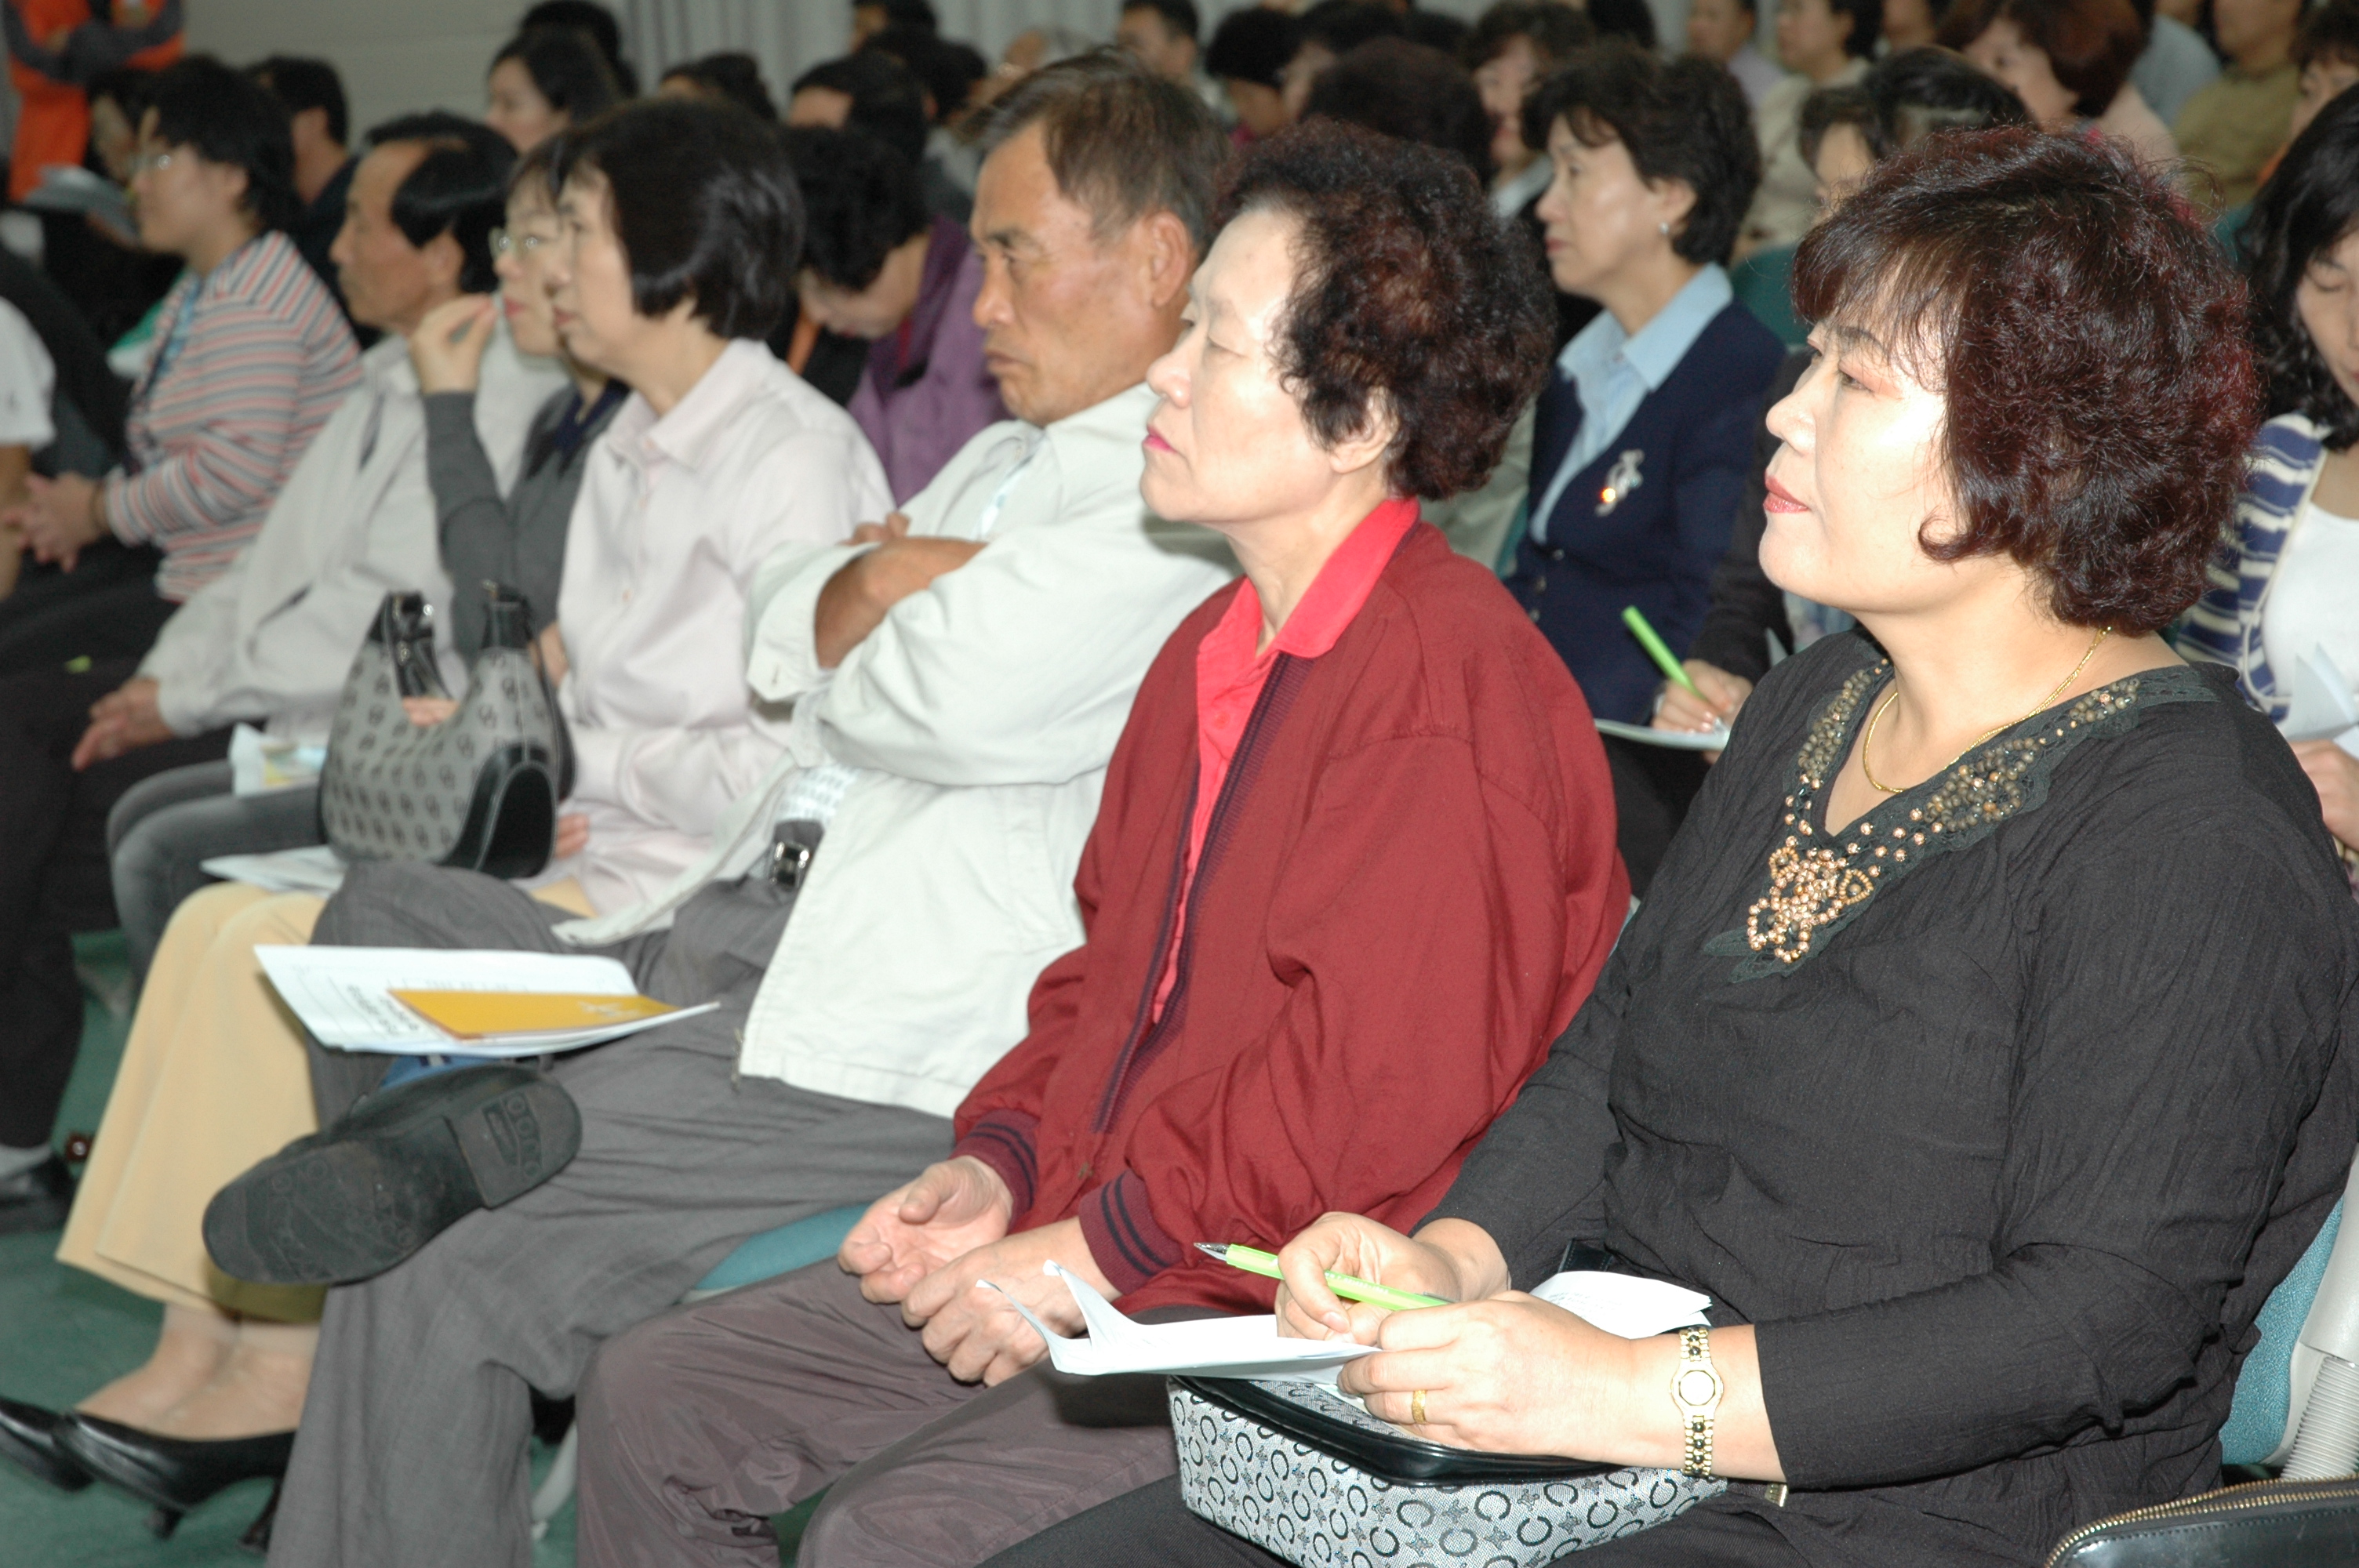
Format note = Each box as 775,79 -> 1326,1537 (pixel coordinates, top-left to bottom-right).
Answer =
2244,89 -> 2359,452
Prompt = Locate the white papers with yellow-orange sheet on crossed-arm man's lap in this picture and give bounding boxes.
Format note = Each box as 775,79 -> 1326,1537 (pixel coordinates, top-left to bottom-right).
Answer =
255,946 -> 717,1058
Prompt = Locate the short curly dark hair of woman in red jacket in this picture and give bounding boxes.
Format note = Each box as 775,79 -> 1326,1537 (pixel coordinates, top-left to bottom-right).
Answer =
1217,120 -> 1554,500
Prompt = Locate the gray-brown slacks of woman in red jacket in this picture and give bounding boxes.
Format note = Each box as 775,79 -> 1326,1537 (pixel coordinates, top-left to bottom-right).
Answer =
573,1261 -> 1180,1568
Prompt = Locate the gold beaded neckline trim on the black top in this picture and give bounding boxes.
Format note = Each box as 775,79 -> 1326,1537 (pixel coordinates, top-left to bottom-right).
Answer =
1703,660 -> 2218,981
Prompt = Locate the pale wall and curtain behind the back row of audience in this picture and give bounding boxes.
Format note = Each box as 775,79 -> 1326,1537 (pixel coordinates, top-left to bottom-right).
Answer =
189,0 -> 1698,143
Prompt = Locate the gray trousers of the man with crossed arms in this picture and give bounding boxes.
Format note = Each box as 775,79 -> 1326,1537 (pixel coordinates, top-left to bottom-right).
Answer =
271,866 -> 951,1568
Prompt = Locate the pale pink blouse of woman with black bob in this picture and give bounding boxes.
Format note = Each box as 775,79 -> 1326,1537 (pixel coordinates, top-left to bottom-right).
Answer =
550,339 -> 892,910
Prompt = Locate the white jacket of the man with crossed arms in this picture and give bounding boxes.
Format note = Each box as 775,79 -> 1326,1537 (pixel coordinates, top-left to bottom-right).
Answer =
559,387 -> 1234,1116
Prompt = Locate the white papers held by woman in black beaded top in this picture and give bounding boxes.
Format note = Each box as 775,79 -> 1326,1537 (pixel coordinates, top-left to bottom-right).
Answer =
976,1259 -> 1713,1384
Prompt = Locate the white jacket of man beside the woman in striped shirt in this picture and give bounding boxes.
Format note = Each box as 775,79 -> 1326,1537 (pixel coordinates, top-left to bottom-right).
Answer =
139,323 -> 564,740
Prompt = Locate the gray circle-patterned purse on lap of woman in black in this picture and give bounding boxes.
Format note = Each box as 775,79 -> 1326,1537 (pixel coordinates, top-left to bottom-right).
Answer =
1170,1377 -> 1727,1568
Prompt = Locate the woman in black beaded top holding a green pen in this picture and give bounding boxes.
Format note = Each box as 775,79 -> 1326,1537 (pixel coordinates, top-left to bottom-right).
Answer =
986,129 -> 2359,1568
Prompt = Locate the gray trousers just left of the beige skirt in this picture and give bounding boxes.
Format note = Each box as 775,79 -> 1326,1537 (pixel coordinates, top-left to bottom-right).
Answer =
106,761 -> 321,981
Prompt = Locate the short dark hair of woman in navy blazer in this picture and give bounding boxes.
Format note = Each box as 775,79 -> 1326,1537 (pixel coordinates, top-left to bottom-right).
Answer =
1524,38 -> 1762,264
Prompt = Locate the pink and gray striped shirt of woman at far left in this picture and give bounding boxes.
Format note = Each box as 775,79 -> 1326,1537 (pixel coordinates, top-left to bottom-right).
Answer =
106,231 -> 361,601
